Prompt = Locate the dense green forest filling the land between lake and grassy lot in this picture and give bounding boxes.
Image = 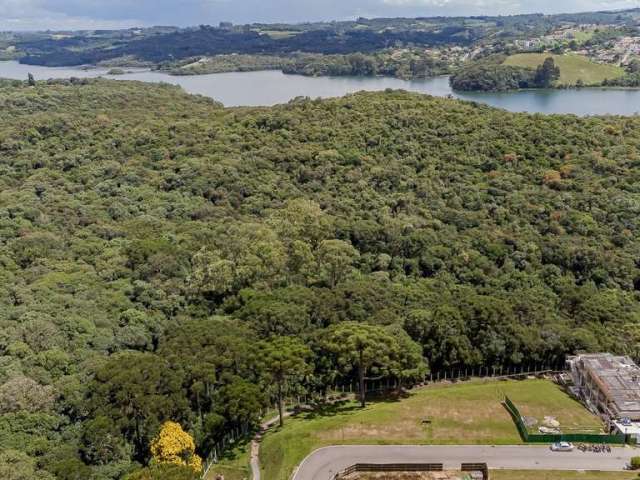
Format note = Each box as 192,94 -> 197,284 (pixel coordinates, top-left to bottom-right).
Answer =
0,80 -> 640,480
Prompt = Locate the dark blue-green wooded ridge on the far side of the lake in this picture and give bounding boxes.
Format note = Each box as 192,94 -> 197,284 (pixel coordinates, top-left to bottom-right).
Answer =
16,24 -> 480,66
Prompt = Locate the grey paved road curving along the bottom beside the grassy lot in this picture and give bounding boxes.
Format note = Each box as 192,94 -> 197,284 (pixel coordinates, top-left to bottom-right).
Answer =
293,445 -> 638,480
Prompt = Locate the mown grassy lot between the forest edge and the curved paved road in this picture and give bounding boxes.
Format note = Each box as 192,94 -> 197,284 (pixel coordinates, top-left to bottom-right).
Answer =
260,380 -> 600,480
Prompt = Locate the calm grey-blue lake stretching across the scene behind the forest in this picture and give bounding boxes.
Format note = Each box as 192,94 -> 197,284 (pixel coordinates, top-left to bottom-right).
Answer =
0,62 -> 640,115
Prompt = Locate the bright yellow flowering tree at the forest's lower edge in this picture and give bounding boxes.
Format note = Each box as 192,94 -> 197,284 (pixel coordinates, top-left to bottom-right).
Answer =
151,422 -> 202,472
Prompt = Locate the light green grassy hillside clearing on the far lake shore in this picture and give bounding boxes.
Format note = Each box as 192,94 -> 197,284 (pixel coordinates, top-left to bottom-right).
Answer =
504,53 -> 624,85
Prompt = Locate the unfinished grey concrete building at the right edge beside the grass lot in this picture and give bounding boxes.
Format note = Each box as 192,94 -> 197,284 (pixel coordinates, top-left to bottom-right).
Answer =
568,353 -> 640,423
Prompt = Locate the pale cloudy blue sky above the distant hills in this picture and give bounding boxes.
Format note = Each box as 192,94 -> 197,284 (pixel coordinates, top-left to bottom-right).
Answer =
0,0 -> 640,30
